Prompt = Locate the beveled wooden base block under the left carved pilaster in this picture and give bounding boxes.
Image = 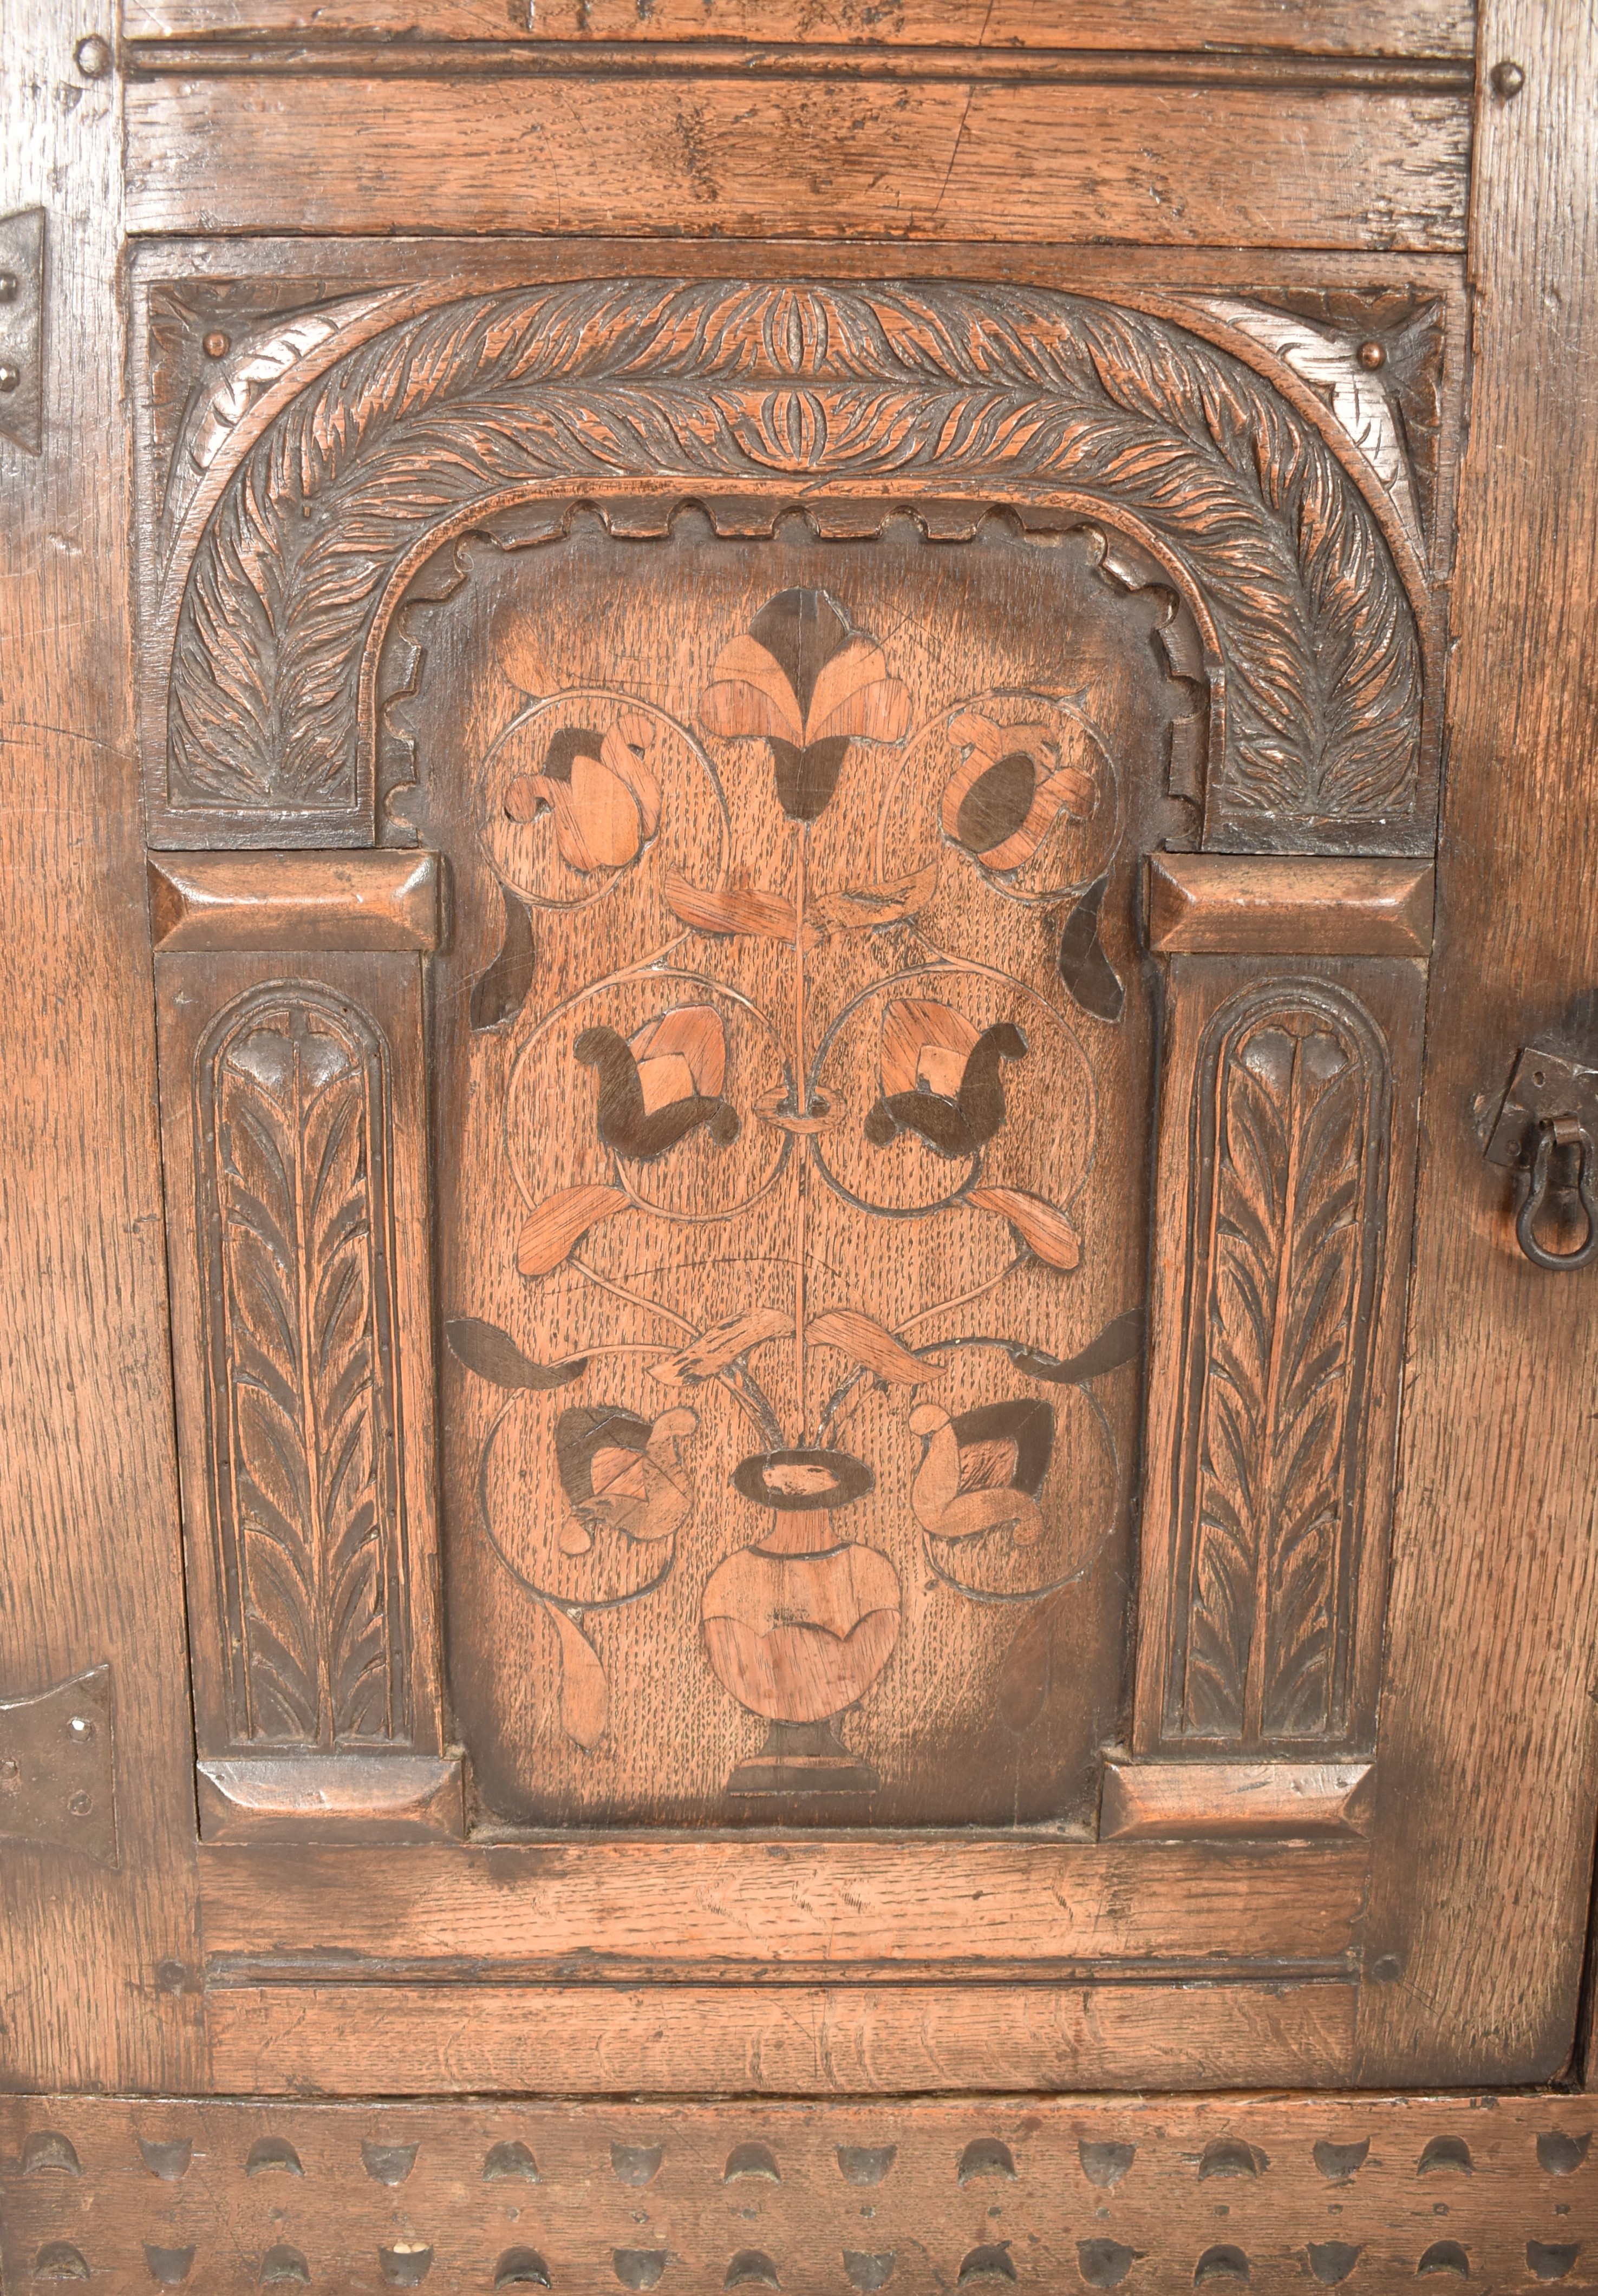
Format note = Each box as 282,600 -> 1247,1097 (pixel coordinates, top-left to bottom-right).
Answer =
195,1750 -> 466,1844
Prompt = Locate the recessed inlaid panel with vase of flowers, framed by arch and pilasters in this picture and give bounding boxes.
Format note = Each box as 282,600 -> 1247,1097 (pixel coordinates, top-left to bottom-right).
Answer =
401,507 -> 1203,1826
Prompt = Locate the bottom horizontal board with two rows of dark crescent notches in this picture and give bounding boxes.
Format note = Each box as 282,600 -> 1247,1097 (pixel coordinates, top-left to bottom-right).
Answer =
0,2094 -> 1598,2296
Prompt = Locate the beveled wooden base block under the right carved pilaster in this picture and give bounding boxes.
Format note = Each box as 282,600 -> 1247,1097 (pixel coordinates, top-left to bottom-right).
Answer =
1100,1761 -> 1371,1841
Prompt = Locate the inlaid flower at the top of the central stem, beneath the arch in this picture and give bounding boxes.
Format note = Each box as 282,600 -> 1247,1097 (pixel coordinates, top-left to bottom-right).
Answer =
698,590 -> 909,822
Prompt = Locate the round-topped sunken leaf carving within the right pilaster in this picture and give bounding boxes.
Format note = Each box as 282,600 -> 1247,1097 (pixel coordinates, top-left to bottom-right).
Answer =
1166,980 -> 1391,1747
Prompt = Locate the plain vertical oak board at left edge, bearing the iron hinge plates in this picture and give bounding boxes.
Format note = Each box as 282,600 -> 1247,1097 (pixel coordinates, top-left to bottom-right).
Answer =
0,0 -> 202,2087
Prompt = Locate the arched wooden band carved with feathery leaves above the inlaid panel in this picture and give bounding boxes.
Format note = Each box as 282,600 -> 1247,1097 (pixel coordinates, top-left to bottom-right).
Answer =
168,280 -> 1421,838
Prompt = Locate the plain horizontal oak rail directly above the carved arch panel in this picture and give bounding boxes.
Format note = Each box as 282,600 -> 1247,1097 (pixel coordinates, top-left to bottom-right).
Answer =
126,74 -> 1470,250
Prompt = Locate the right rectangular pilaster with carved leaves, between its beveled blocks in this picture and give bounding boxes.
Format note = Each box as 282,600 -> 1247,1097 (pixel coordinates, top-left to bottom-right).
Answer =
1139,957 -> 1421,1752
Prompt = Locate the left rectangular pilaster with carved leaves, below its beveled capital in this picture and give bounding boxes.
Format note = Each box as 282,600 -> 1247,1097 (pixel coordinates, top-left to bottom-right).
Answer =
159,955 -> 448,1830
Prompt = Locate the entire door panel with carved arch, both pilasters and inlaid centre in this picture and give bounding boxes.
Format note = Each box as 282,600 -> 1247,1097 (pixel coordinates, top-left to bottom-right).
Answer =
140,276 -> 1446,1839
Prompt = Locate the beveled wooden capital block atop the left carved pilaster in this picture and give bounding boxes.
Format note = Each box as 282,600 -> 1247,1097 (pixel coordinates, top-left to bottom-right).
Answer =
149,852 -> 443,953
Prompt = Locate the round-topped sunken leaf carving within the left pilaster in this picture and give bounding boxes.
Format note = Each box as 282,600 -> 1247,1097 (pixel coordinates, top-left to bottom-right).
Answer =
195,983 -> 411,1747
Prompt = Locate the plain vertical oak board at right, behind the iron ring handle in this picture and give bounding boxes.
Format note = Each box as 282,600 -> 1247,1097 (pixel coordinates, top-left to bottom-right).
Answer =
1359,0 -> 1598,2083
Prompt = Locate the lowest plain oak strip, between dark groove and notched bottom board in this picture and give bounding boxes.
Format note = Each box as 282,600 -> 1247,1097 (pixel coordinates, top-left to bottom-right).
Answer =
196,1979 -> 1357,2096
